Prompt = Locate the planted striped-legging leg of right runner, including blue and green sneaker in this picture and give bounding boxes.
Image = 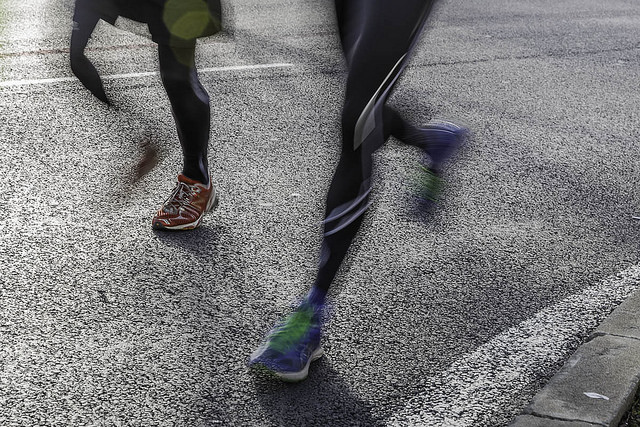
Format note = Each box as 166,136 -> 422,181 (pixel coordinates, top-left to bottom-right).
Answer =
249,0 -> 440,381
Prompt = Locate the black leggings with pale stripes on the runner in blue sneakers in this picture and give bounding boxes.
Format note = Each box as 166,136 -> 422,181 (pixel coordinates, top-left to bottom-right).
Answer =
314,0 -> 433,290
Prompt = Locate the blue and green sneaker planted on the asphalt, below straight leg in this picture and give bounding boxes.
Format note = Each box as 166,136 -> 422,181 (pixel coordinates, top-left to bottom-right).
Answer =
249,300 -> 324,382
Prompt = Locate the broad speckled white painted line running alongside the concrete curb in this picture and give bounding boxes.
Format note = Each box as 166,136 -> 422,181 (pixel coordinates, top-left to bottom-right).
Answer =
388,265 -> 640,427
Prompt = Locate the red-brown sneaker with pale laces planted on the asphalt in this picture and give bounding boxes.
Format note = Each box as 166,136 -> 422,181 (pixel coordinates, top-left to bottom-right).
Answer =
152,174 -> 218,230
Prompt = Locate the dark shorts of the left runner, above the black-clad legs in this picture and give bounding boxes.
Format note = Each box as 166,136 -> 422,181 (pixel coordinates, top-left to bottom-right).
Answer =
77,0 -> 222,47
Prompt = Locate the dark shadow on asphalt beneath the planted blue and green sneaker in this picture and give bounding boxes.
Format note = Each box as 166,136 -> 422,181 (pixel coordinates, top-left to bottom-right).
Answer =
253,357 -> 383,426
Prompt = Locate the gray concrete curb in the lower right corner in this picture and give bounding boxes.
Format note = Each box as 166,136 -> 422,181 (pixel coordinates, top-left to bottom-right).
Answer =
510,291 -> 640,427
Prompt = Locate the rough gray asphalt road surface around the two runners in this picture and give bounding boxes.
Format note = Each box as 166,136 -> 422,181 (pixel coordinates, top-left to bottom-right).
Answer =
0,0 -> 640,426
